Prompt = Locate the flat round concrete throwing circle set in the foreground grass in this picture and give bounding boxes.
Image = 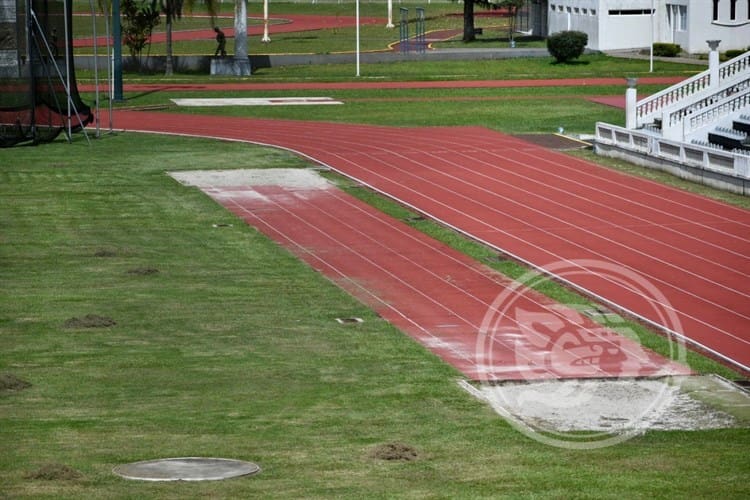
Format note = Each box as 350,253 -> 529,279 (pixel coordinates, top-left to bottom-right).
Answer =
112,457 -> 260,481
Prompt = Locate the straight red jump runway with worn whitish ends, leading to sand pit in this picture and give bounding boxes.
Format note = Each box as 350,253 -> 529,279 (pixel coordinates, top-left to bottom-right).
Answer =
176,171 -> 690,381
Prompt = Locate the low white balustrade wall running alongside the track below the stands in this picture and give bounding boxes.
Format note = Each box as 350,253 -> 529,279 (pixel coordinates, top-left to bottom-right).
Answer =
595,122 -> 750,180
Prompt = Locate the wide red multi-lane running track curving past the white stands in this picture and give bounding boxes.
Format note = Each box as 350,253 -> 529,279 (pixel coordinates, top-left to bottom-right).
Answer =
116,112 -> 750,376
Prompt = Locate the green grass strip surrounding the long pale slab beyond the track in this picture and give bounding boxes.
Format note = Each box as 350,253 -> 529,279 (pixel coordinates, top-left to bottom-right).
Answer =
91,83 -> 624,134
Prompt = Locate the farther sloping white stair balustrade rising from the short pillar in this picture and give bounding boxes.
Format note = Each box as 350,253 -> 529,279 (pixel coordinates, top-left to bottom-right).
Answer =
635,52 -> 750,127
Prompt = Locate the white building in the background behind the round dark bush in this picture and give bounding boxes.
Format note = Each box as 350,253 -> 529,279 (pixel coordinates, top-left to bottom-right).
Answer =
548,0 -> 750,53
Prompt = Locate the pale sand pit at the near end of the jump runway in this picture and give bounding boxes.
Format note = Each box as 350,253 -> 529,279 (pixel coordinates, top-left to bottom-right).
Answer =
460,375 -> 750,448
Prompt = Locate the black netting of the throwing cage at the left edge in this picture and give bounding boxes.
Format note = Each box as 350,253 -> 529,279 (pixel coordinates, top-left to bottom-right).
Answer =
0,0 -> 94,147
